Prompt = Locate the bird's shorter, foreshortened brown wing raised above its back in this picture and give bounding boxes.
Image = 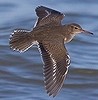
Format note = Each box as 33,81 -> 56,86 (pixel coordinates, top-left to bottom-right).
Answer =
35,6 -> 64,27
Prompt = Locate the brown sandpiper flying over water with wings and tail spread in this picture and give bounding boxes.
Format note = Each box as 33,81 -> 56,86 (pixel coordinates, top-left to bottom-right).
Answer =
9,6 -> 93,97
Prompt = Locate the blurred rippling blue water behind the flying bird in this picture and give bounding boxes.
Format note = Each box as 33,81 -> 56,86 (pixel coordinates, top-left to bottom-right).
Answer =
0,0 -> 98,100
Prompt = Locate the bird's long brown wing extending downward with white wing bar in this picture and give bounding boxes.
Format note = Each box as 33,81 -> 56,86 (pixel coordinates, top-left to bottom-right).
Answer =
39,40 -> 70,97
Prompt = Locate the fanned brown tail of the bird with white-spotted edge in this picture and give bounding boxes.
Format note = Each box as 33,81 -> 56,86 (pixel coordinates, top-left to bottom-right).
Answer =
9,30 -> 35,52
